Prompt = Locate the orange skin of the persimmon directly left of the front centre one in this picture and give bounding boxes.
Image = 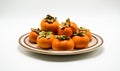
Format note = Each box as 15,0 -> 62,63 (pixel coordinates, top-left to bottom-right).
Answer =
37,34 -> 54,48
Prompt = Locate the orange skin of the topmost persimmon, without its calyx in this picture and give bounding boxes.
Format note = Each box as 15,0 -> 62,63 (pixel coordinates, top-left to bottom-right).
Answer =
40,19 -> 59,34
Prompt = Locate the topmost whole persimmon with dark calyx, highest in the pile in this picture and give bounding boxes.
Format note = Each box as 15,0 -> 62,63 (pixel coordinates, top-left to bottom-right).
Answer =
40,15 -> 59,34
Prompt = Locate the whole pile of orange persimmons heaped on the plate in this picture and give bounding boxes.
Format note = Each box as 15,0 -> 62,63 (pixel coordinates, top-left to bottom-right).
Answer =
29,15 -> 92,51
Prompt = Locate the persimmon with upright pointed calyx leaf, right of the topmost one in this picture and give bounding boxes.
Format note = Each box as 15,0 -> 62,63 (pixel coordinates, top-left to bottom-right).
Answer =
58,19 -> 73,36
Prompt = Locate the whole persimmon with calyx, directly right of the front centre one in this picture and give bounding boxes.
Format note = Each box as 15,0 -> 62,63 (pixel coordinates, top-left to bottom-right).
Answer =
72,31 -> 89,48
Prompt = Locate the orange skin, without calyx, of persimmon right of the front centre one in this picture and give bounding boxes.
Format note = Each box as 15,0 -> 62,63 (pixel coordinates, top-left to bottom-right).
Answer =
72,35 -> 89,48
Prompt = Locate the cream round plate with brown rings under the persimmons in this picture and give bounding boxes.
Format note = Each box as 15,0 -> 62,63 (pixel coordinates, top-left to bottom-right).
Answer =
19,33 -> 103,55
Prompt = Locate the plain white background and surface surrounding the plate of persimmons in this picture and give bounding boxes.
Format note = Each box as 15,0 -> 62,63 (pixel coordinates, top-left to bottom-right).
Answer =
0,0 -> 120,71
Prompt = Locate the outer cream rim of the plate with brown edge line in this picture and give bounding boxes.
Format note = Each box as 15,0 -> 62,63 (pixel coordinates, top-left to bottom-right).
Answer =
18,33 -> 104,55
